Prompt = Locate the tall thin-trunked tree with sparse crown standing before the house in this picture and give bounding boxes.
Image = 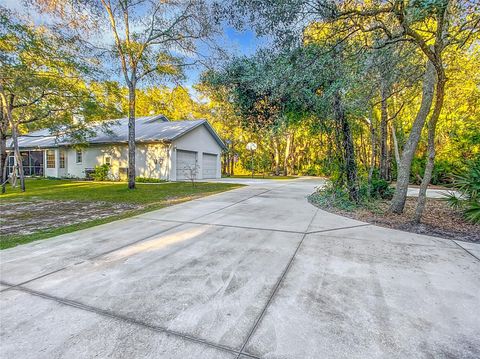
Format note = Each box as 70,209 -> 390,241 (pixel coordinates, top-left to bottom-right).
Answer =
35,0 -> 218,189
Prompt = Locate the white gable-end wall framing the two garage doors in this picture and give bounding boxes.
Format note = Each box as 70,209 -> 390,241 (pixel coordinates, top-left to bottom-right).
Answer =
170,126 -> 222,181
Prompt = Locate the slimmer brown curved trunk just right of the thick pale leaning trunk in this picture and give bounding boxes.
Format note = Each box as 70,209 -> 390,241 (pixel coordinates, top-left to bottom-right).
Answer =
414,71 -> 446,223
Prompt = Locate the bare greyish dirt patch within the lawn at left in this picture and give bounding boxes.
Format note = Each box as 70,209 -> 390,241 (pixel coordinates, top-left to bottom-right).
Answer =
0,200 -> 142,235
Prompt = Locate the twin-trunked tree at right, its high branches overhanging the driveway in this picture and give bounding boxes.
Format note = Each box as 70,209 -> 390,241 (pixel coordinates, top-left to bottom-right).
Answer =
219,0 -> 480,218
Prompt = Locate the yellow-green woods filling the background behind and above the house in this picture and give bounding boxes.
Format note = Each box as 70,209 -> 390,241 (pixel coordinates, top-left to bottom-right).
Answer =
0,0 -> 480,221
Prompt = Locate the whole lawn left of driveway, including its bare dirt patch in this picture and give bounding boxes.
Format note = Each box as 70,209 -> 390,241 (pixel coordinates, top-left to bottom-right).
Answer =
0,179 -> 240,249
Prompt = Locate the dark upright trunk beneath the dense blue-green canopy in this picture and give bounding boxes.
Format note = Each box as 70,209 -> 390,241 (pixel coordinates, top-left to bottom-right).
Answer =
333,90 -> 358,202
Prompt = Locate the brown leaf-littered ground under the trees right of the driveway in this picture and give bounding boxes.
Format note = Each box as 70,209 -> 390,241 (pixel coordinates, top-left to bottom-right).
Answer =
316,198 -> 480,242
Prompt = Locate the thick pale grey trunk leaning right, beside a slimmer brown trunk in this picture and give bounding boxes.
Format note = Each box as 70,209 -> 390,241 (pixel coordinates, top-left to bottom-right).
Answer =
390,61 -> 436,214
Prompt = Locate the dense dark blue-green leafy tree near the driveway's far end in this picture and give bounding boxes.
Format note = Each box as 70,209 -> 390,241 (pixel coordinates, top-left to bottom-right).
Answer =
204,44 -> 366,201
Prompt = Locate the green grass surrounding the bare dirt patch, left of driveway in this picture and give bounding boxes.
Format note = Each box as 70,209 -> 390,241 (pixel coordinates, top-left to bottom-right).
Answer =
0,179 -> 241,249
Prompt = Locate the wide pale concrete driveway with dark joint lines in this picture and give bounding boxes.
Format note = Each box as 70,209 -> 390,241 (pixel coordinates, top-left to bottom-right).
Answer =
0,179 -> 480,359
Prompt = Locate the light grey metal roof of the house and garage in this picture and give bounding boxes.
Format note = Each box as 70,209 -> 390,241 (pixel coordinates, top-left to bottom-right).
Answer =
7,115 -> 225,149
